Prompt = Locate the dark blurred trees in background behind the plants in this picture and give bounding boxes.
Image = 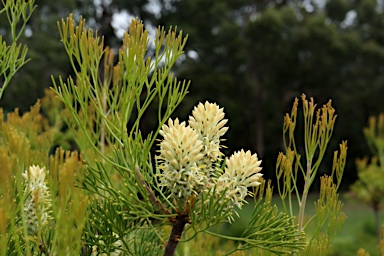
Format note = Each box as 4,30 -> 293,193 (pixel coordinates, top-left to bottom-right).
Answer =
0,0 -> 384,190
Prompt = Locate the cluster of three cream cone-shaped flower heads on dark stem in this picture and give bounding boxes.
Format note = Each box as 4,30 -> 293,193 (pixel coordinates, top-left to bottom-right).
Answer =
158,102 -> 262,211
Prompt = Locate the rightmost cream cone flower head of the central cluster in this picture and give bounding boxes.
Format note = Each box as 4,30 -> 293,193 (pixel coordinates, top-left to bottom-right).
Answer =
217,150 -> 263,209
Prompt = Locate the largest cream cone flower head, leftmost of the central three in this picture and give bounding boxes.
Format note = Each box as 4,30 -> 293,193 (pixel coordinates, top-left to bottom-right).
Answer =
158,119 -> 206,210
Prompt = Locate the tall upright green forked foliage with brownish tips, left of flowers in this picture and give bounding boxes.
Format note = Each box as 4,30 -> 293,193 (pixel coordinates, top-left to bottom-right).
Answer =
54,14 -> 188,161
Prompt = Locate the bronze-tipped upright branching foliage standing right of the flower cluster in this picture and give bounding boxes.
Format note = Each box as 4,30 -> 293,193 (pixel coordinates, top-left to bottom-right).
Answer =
276,95 -> 347,255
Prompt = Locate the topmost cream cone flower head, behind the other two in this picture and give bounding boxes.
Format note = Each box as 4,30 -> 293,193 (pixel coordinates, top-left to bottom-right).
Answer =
189,101 -> 228,162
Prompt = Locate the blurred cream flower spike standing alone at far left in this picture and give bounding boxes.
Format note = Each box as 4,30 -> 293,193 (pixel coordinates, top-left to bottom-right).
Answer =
22,165 -> 51,235
